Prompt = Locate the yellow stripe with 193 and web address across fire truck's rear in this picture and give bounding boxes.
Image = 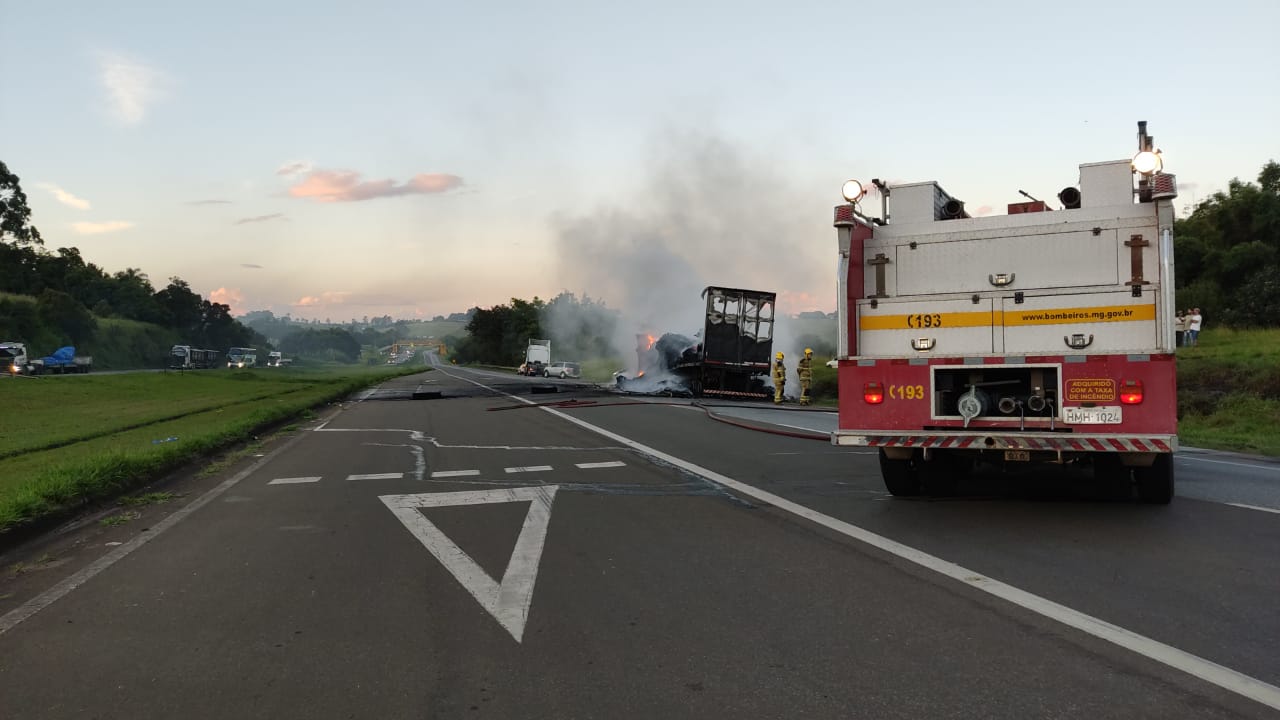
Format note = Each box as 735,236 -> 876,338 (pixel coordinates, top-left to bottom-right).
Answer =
859,305 -> 1156,331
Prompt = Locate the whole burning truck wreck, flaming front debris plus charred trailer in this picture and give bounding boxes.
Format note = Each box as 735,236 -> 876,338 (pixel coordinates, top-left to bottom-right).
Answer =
616,287 -> 777,398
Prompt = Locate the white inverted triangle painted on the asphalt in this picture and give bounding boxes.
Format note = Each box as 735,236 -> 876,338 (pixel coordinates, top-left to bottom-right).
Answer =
379,486 -> 559,643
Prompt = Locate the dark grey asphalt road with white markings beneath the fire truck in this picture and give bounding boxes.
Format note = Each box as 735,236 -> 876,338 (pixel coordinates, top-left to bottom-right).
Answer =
0,368 -> 1280,719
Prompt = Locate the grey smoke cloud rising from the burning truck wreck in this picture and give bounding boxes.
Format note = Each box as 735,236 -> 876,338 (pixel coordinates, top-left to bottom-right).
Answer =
553,131 -> 836,366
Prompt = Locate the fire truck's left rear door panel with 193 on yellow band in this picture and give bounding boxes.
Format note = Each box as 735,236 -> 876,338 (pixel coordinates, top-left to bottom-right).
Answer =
858,297 -> 998,357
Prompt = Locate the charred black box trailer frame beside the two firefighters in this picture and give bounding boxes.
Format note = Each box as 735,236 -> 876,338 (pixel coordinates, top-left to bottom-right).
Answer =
671,286 -> 777,397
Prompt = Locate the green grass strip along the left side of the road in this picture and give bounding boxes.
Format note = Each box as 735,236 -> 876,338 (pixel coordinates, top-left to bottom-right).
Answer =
0,366 -> 422,530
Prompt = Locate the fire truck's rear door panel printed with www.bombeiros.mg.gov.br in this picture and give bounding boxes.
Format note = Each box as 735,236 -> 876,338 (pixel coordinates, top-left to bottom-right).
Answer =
1000,286 -> 1160,355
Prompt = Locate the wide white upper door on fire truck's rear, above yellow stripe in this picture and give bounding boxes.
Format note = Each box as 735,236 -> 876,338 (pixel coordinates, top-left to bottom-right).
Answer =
893,229 -> 1128,295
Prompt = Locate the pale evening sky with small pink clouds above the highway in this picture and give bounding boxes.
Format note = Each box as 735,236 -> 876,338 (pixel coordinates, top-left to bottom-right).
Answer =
0,0 -> 1280,322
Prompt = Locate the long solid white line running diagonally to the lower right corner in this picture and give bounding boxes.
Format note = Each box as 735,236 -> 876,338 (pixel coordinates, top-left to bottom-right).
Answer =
430,361 -> 1280,710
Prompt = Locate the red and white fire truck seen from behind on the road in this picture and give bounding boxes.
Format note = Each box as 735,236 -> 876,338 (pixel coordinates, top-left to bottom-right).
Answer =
832,122 -> 1178,503
